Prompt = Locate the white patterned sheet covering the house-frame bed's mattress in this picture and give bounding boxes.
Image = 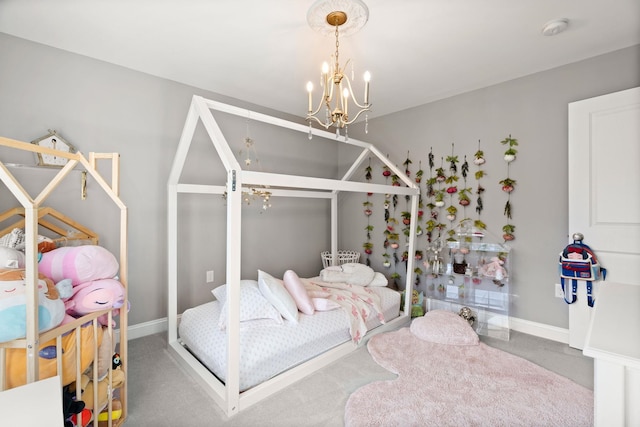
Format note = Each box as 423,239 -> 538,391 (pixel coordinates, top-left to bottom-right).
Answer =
178,287 -> 400,391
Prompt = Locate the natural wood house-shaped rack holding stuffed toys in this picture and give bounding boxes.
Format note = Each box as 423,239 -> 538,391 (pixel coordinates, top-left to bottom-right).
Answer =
0,137 -> 128,427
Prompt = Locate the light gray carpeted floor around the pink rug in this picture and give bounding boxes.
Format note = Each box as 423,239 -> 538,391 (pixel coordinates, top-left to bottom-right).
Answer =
124,331 -> 593,427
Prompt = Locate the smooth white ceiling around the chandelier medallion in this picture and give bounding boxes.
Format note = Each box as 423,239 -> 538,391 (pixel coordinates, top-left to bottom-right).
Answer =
0,0 -> 640,117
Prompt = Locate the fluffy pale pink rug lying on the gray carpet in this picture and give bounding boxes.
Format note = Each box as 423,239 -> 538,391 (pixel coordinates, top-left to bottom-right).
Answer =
345,310 -> 593,427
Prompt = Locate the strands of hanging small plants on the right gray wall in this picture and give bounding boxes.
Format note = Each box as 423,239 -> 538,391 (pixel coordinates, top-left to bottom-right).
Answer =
363,135 -> 518,295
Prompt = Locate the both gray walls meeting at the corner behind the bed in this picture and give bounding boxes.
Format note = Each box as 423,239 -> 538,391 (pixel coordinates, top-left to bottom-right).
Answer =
0,30 -> 640,327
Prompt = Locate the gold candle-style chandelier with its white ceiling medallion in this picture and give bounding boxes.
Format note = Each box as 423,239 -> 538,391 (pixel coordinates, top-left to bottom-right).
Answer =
306,0 -> 371,138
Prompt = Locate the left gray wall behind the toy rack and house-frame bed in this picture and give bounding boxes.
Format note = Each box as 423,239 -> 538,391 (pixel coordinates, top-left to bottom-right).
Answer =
0,33 -> 337,324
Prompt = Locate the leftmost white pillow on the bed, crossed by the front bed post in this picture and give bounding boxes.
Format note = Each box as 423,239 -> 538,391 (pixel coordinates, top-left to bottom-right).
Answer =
211,280 -> 282,330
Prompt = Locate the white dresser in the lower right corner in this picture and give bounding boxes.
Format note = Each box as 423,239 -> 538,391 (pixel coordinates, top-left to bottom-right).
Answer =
583,282 -> 640,427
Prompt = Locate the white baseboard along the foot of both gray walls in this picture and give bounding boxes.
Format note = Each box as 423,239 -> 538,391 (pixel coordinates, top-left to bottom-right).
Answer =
121,317 -> 569,344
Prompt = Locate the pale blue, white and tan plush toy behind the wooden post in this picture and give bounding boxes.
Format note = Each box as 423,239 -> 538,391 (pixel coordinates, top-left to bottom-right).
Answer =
0,268 -> 71,342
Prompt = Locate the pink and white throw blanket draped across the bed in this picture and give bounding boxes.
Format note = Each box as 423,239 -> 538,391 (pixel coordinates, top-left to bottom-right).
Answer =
303,279 -> 385,344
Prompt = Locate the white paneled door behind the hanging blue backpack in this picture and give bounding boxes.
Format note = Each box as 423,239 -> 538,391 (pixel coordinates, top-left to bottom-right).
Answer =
569,87 -> 640,349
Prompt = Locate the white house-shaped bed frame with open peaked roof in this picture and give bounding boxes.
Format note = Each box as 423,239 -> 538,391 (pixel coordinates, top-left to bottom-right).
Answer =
168,96 -> 420,416
